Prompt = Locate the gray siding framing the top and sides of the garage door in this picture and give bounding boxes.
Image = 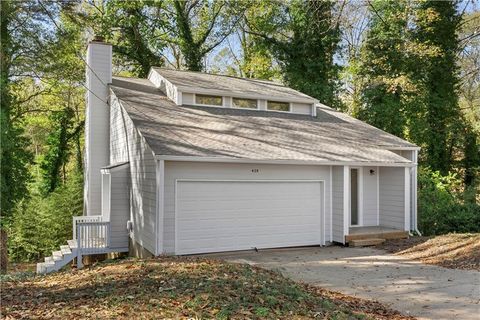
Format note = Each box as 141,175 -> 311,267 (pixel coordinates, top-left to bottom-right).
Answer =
163,161 -> 330,254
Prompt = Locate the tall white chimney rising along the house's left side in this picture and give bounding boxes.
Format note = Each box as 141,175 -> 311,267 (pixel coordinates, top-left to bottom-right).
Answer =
84,37 -> 112,216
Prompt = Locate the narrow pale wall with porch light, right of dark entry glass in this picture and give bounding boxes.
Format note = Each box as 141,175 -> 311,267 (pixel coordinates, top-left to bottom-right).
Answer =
363,167 -> 378,226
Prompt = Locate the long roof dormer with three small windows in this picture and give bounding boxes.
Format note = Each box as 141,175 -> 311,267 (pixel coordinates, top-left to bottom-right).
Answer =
148,67 -> 318,116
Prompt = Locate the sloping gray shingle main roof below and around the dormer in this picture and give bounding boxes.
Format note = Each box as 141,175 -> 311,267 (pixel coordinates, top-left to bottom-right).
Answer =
111,77 -> 415,163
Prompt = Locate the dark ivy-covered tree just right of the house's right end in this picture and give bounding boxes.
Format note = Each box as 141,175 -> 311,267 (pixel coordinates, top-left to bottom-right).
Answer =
415,0 -> 461,174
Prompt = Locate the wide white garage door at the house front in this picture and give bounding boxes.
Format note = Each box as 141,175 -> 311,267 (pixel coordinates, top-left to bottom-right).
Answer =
175,181 -> 323,254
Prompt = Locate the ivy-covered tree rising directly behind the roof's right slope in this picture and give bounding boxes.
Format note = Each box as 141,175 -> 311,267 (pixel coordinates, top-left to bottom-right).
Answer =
355,0 -> 421,137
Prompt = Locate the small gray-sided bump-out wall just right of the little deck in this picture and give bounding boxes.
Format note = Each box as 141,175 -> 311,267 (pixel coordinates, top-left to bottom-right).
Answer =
110,166 -> 130,248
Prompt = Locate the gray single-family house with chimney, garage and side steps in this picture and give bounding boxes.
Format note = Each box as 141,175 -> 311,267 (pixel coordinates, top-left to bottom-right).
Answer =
38,39 -> 419,273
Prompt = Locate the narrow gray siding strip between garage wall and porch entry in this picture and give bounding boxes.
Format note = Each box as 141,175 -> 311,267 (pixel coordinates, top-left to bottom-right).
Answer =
332,166 -> 345,243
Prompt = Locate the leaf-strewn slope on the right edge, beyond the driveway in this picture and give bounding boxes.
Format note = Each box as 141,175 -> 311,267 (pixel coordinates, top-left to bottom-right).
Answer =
377,233 -> 480,271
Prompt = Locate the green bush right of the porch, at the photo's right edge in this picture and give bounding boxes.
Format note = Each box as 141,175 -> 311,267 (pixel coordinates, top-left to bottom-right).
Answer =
418,168 -> 480,235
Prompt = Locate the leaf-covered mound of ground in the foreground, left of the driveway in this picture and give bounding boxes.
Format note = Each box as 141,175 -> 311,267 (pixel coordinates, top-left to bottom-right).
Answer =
1,257 -> 412,319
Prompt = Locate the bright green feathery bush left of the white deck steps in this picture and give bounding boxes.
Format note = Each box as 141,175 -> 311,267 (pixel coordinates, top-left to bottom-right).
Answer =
8,176 -> 83,261
